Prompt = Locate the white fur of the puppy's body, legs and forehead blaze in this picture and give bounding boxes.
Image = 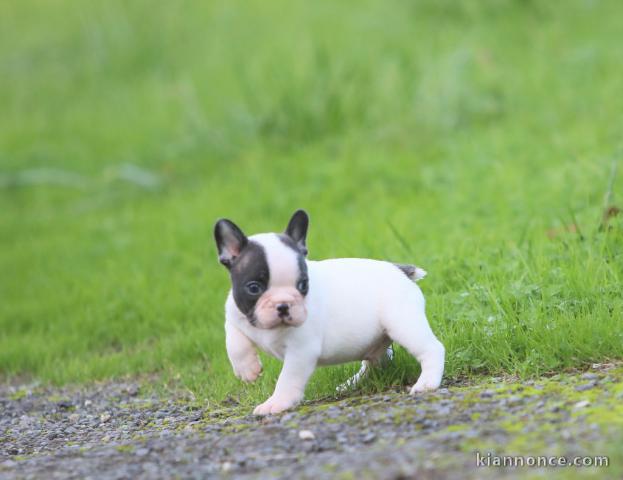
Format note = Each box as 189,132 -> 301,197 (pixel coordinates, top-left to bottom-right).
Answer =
225,234 -> 444,415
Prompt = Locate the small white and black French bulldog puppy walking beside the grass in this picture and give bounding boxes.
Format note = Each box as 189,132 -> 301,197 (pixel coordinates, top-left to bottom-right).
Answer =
214,210 -> 444,415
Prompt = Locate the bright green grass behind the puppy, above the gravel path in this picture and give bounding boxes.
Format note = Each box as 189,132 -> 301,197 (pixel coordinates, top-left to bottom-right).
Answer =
0,0 -> 623,402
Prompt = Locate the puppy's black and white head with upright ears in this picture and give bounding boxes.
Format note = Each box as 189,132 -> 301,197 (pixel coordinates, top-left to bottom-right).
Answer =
214,210 -> 309,328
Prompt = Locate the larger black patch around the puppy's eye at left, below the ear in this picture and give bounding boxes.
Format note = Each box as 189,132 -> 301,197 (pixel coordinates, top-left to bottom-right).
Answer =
230,240 -> 270,324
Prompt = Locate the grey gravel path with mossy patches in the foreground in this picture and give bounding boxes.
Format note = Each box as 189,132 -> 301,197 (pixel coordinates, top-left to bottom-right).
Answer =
0,364 -> 623,479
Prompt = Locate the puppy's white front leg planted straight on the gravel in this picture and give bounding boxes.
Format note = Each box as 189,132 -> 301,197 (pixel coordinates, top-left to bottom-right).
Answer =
253,351 -> 318,415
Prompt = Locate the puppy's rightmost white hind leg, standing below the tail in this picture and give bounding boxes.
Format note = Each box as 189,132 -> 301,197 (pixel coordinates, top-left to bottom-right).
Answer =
384,296 -> 445,394
